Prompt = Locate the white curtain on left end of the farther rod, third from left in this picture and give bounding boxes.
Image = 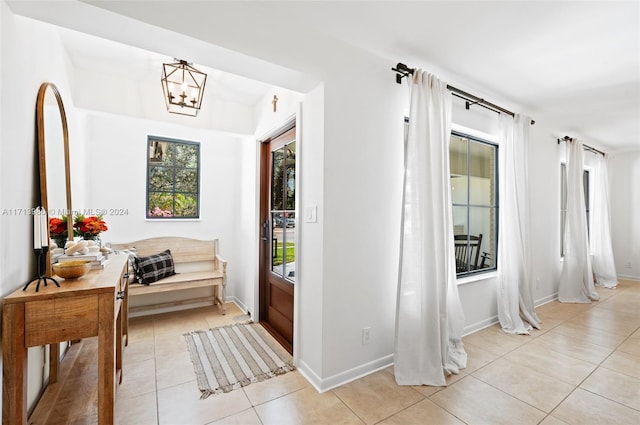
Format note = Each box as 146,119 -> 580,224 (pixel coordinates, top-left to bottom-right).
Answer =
558,139 -> 600,303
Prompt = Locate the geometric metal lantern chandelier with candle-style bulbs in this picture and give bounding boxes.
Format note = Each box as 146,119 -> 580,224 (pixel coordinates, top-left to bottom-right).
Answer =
160,59 -> 207,117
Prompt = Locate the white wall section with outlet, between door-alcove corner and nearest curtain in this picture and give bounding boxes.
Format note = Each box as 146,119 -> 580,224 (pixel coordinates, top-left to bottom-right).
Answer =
316,52 -> 405,380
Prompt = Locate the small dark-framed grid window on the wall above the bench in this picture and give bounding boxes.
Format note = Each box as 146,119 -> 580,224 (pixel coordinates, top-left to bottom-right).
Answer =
147,136 -> 200,219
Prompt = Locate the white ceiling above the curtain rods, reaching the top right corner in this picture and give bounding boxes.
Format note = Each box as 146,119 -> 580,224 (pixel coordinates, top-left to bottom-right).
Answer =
7,0 -> 640,152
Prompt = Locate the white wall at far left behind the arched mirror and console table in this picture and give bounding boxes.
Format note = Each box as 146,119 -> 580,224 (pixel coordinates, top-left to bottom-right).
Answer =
0,6 -> 81,405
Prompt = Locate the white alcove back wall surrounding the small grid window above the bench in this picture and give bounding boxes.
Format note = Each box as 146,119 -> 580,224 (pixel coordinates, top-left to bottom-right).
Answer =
77,112 -> 252,304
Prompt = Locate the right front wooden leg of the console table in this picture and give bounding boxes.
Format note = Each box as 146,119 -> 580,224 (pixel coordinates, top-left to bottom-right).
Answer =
98,293 -> 116,425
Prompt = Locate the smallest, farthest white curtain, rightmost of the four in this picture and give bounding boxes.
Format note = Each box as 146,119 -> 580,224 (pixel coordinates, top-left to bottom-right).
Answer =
589,154 -> 618,288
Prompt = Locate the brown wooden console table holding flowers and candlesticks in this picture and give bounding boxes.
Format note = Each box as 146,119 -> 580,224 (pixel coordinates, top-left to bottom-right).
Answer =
2,255 -> 128,425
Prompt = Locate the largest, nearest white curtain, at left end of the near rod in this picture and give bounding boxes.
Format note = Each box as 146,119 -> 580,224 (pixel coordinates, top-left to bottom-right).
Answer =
394,70 -> 467,386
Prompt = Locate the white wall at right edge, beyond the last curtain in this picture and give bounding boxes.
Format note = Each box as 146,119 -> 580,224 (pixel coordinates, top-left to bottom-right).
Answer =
608,152 -> 640,280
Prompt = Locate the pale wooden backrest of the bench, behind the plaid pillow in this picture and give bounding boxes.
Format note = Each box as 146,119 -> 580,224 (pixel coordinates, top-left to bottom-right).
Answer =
111,236 -> 218,269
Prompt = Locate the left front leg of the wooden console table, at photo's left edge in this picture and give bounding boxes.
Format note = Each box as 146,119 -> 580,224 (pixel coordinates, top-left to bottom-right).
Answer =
2,303 -> 27,425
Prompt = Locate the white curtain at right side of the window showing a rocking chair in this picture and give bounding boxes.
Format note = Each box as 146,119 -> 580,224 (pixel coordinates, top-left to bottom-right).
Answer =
498,114 -> 540,334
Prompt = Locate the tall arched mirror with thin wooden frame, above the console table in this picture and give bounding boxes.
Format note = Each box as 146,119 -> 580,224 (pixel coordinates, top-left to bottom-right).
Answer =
36,83 -> 73,276
